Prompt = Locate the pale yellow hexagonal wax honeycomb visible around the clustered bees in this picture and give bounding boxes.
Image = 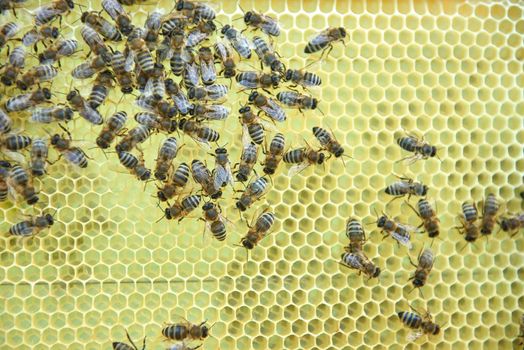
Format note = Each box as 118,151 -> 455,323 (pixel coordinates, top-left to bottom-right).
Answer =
0,0 -> 524,349
